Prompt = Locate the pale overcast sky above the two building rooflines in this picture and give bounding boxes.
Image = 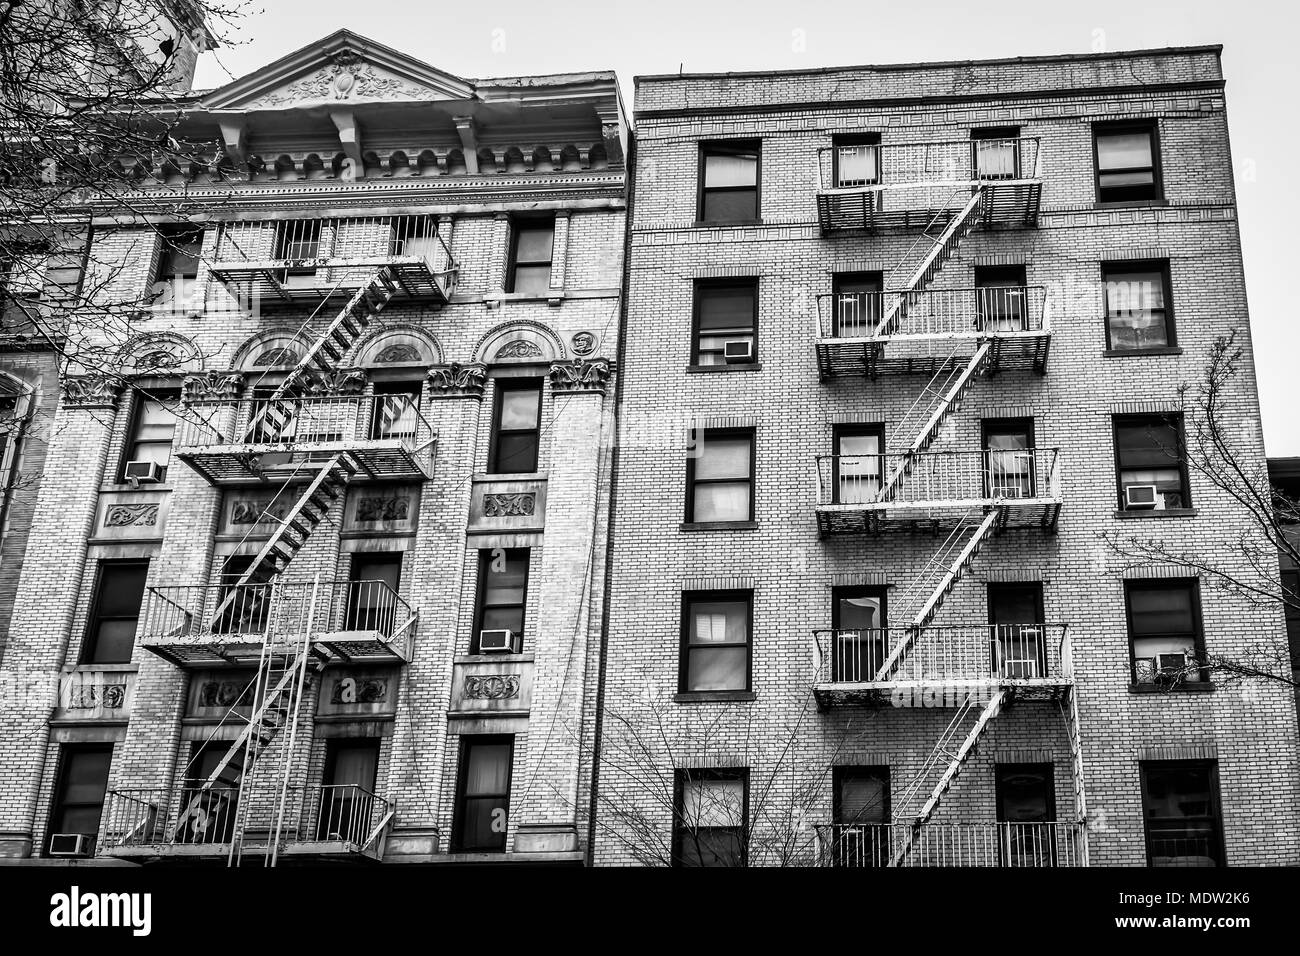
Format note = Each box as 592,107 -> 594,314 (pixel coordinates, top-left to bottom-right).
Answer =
195,0 -> 1300,455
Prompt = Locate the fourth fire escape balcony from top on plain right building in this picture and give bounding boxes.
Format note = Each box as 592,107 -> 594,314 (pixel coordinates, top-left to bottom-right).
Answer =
813,624 -> 1074,708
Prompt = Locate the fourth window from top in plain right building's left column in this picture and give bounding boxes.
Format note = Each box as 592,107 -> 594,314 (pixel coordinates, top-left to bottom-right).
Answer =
679,591 -> 754,693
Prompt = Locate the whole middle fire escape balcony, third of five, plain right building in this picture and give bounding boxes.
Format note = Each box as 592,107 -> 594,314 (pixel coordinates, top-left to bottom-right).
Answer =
816,449 -> 1062,537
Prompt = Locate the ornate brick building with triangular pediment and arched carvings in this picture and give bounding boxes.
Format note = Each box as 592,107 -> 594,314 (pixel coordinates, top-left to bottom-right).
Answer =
0,31 -> 627,862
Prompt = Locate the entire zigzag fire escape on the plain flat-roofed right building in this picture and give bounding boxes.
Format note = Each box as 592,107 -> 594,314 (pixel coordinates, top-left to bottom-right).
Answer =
814,138 -> 1087,866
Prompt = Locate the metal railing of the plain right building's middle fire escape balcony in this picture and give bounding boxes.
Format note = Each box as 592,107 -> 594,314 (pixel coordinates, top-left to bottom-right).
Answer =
816,449 -> 1061,507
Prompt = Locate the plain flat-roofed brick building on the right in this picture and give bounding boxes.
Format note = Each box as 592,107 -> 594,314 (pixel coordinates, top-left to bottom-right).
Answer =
593,47 -> 1300,866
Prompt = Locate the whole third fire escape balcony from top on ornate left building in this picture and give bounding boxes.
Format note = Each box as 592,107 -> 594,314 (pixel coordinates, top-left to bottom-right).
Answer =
139,581 -> 419,667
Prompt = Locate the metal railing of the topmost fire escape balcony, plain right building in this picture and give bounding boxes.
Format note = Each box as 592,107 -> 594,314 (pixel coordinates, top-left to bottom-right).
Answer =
818,137 -> 1043,193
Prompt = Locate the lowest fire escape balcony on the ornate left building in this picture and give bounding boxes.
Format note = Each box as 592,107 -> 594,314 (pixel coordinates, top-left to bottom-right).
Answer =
98,780 -> 397,860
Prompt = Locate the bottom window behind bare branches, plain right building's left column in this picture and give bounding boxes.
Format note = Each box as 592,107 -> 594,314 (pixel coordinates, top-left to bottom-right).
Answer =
672,769 -> 749,866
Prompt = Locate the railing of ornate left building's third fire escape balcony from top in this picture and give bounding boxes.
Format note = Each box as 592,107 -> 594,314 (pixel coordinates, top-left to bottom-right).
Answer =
140,580 -> 417,659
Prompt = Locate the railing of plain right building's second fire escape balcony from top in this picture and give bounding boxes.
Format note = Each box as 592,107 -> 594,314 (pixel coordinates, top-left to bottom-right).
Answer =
815,286 -> 1050,342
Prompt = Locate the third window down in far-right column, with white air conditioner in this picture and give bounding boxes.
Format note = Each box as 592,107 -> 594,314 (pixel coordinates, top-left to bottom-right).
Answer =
1115,415 -> 1192,511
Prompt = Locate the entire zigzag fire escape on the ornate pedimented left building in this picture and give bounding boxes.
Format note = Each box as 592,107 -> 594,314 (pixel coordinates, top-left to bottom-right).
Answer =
101,217 -> 456,866
